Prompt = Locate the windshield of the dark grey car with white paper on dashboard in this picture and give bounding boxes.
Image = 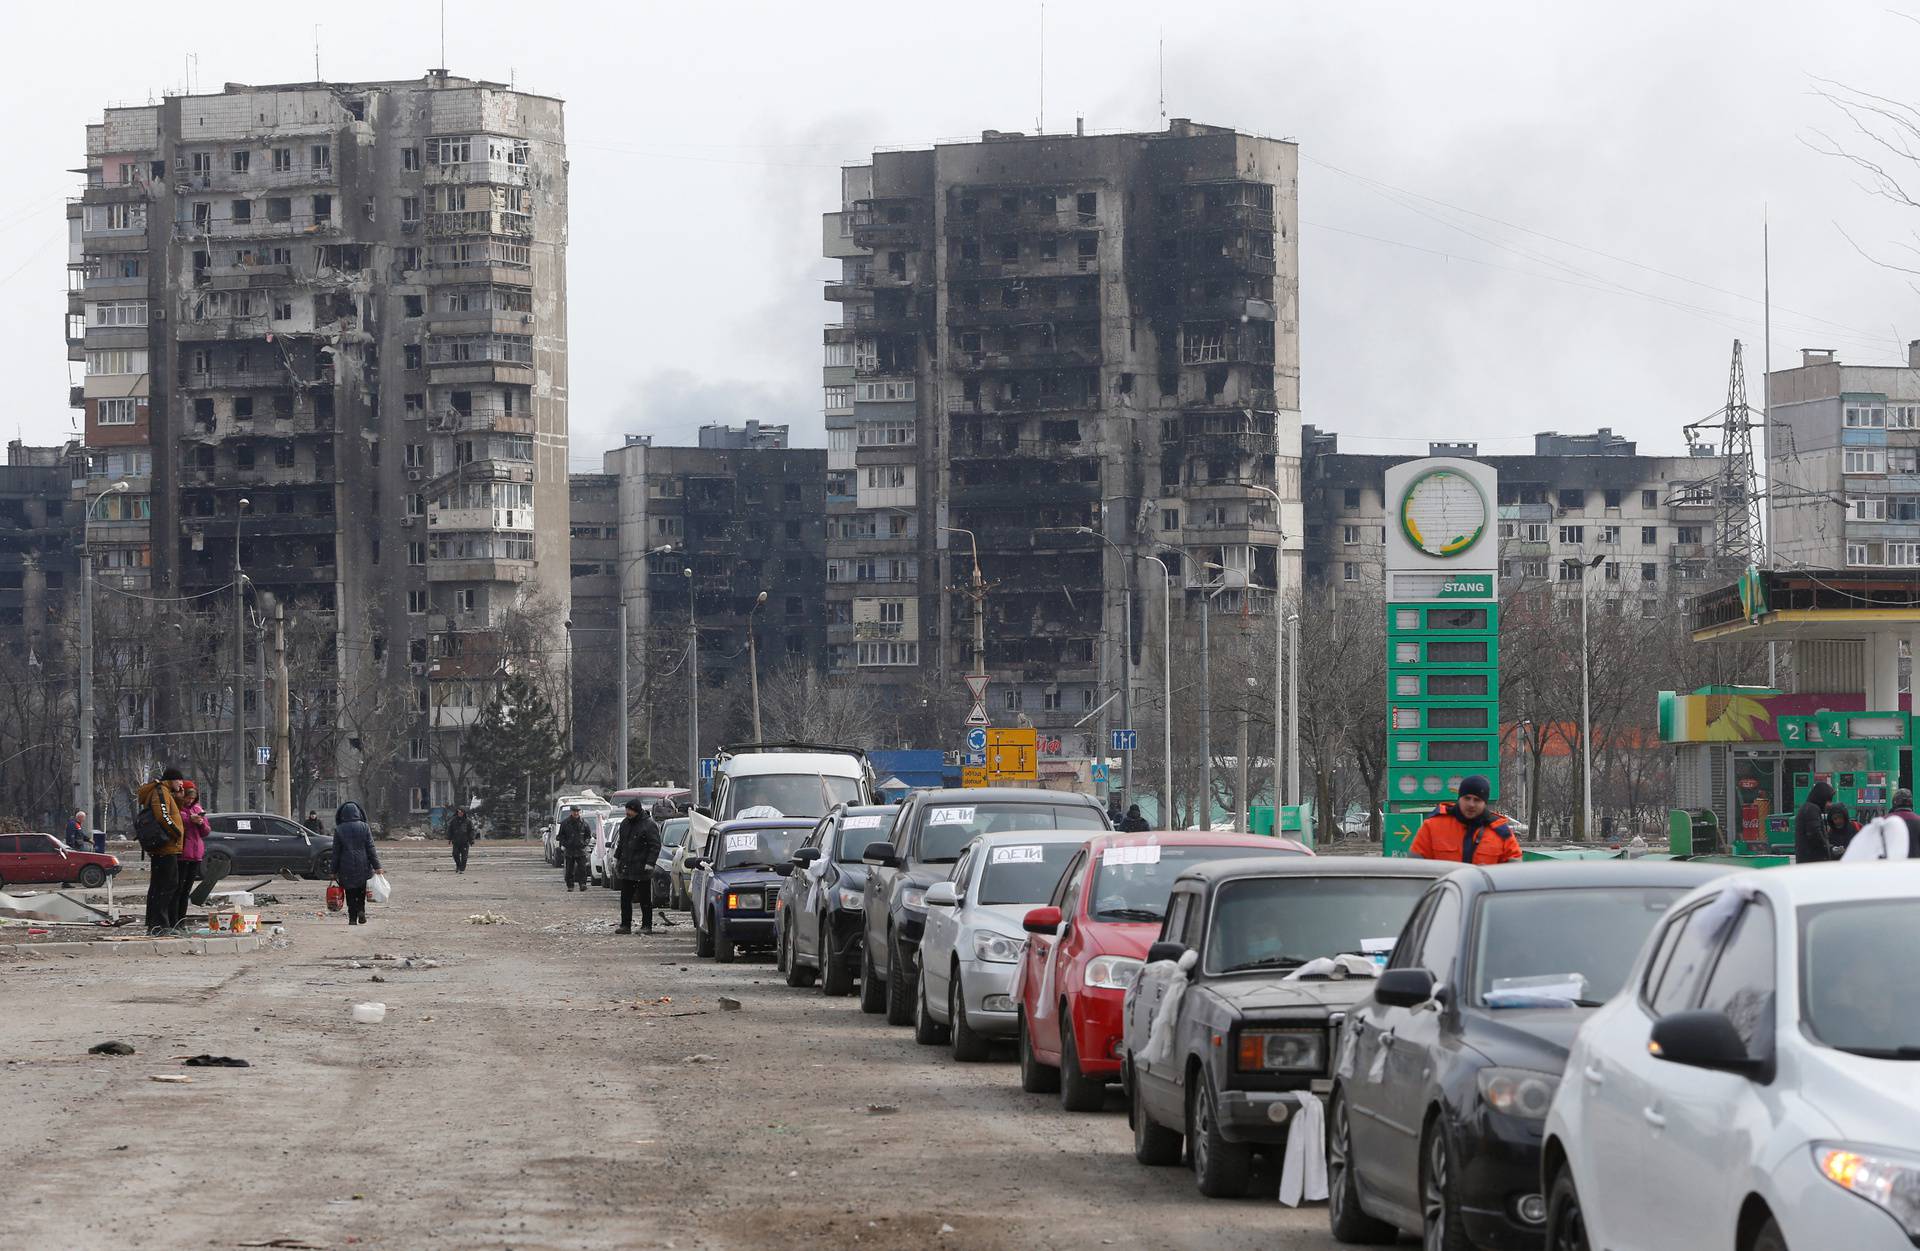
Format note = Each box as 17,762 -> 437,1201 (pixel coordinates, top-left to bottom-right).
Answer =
1473,886 -> 1682,1007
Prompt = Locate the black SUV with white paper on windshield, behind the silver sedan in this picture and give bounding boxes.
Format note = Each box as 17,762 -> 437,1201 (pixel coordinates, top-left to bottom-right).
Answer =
860,787 -> 1114,1025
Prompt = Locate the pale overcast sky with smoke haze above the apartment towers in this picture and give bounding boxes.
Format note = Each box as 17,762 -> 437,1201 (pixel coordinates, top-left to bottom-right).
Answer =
15,0 -> 1920,468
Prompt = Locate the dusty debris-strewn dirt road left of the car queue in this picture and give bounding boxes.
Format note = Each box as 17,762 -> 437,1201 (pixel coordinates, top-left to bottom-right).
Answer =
0,844 -> 1359,1251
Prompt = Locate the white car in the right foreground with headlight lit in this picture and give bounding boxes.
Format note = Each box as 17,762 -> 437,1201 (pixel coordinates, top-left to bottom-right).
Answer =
1542,860 -> 1920,1251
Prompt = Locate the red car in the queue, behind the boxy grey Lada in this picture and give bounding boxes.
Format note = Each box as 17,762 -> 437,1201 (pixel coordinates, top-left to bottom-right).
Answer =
1014,831 -> 1313,1113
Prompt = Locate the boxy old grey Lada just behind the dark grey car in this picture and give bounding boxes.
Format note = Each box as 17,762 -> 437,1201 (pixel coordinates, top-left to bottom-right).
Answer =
1121,856 -> 1459,1197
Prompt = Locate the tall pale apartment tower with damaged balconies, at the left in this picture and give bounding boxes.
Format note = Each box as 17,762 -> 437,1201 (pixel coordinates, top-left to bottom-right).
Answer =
69,69 -> 568,821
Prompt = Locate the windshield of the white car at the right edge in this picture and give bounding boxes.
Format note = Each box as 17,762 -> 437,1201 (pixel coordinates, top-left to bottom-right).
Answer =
1799,900 -> 1920,1059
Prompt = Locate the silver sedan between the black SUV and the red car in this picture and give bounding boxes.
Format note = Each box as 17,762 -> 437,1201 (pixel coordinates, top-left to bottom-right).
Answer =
914,829 -> 1096,1059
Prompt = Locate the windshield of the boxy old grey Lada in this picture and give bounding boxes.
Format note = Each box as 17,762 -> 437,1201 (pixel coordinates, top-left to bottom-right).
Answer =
1206,875 -> 1432,973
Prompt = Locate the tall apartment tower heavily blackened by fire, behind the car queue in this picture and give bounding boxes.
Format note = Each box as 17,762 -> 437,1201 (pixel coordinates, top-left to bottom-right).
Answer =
824,119 -> 1300,756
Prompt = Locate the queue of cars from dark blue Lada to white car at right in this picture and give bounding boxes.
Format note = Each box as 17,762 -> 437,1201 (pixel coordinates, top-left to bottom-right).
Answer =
684,752 -> 1920,1251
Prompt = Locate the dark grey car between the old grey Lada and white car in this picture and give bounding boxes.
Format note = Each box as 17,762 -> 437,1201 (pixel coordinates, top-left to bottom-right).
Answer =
1327,860 -> 1726,1251
